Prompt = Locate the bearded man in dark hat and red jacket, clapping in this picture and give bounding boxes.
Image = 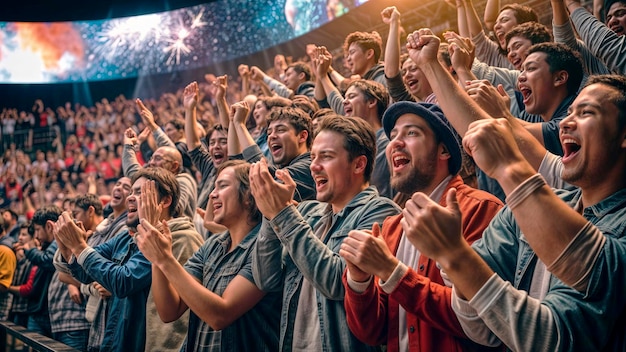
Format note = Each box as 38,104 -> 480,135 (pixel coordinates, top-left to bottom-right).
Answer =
340,102 -> 502,351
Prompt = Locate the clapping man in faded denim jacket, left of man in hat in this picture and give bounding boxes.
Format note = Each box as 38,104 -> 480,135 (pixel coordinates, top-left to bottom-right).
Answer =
250,115 -> 399,351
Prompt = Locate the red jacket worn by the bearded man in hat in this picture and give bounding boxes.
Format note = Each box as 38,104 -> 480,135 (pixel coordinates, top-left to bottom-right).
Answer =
343,176 -> 502,352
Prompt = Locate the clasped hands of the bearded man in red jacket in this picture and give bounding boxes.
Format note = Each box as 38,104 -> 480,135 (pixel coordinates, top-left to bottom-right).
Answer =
339,223 -> 398,282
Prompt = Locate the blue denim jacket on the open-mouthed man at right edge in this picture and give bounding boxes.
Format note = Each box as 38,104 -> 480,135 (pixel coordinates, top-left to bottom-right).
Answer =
461,189 -> 626,351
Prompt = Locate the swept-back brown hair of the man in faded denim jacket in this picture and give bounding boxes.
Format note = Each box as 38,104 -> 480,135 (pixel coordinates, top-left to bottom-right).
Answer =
317,114 -> 376,182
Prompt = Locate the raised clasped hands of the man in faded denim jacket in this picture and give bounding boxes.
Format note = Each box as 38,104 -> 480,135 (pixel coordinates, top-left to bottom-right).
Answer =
250,159 -> 296,220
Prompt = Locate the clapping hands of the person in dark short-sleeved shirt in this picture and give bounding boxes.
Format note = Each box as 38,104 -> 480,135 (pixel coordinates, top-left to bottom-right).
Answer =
135,219 -> 174,266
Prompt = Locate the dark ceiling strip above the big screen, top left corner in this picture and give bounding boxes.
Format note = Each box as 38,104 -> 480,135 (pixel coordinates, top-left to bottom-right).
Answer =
0,0 -> 215,22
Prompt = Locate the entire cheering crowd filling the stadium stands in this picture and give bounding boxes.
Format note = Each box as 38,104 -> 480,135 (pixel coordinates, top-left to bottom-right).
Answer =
0,0 -> 626,351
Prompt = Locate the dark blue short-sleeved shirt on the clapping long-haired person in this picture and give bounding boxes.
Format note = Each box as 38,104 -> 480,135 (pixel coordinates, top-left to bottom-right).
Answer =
183,225 -> 281,351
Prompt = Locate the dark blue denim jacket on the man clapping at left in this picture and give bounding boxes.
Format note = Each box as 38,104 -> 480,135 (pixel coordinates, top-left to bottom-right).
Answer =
69,230 -> 152,351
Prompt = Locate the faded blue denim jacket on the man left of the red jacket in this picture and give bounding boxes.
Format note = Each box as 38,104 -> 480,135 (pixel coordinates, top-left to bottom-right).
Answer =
252,186 -> 400,351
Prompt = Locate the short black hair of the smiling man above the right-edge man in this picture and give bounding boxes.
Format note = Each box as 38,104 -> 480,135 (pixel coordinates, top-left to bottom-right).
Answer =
528,42 -> 585,95
